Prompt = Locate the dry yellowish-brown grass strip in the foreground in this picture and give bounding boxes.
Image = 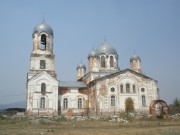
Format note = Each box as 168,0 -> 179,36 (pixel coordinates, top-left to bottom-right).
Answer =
0,118 -> 180,135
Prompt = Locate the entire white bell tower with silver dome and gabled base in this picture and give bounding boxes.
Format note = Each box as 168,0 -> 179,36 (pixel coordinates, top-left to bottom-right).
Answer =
26,21 -> 59,116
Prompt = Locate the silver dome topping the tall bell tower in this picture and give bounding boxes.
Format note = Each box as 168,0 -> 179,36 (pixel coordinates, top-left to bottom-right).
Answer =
33,21 -> 53,36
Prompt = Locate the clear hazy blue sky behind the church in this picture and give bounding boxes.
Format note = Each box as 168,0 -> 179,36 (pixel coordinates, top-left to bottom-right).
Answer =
0,0 -> 180,104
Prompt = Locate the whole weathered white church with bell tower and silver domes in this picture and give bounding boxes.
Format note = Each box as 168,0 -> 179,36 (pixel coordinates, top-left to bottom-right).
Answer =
26,21 -> 159,116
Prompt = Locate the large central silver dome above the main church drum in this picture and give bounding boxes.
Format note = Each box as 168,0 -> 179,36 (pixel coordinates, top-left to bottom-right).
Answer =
96,42 -> 117,55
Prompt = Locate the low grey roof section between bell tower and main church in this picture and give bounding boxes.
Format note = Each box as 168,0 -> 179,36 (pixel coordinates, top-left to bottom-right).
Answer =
59,81 -> 87,88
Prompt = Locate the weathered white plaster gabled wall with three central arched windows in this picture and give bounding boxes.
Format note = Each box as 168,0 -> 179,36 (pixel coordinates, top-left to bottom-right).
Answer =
96,72 -> 158,110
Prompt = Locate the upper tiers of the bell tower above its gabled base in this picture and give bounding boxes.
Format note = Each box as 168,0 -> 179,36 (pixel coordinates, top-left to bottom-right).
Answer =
28,21 -> 56,79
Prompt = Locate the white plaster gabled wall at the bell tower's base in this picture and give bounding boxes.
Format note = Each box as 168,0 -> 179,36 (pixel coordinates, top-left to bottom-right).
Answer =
27,72 -> 58,115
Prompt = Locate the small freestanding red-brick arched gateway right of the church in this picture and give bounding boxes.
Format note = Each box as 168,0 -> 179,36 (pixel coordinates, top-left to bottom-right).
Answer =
149,100 -> 169,118
